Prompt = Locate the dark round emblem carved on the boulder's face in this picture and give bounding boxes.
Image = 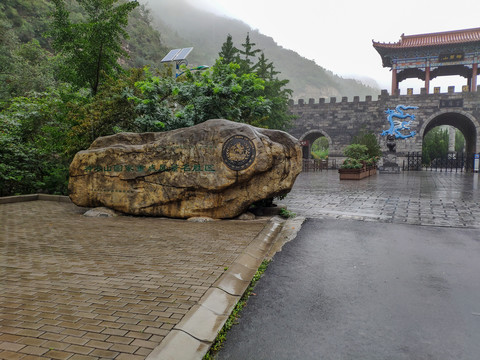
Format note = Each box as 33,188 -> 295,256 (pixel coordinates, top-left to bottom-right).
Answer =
222,135 -> 255,171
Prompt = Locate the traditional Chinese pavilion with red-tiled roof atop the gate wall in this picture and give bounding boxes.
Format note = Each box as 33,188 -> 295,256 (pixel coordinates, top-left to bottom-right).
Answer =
373,28 -> 480,94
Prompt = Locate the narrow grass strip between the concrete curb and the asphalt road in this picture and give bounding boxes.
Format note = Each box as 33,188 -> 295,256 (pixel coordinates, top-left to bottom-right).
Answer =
203,260 -> 271,360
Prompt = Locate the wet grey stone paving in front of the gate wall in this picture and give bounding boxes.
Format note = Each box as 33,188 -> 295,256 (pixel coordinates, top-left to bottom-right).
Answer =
283,170 -> 480,228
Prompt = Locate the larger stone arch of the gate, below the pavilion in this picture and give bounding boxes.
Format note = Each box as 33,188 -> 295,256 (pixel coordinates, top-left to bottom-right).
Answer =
419,110 -> 480,154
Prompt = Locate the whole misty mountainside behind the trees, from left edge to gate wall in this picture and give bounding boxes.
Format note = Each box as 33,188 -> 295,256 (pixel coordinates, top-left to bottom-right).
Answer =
0,0 -> 379,99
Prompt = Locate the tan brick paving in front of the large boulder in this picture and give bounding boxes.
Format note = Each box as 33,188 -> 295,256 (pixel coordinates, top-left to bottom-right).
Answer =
0,201 -> 266,360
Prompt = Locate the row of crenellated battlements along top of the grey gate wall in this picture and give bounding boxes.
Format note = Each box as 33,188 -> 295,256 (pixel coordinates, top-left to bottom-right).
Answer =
288,85 -> 480,106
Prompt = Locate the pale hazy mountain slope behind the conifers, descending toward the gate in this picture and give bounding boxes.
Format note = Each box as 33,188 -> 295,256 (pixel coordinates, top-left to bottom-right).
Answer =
147,0 -> 380,99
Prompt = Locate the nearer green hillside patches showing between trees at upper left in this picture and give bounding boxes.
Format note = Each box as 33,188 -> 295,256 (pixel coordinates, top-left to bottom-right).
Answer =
0,0 -> 167,101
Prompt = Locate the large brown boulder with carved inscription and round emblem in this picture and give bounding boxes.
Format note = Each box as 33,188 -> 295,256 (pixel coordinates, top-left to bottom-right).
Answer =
69,120 -> 302,219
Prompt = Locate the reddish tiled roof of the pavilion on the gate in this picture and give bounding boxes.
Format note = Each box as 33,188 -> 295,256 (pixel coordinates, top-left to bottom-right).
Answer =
373,28 -> 480,49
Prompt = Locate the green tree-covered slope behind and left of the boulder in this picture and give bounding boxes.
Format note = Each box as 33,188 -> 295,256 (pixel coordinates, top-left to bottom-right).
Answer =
0,0 -> 293,196
